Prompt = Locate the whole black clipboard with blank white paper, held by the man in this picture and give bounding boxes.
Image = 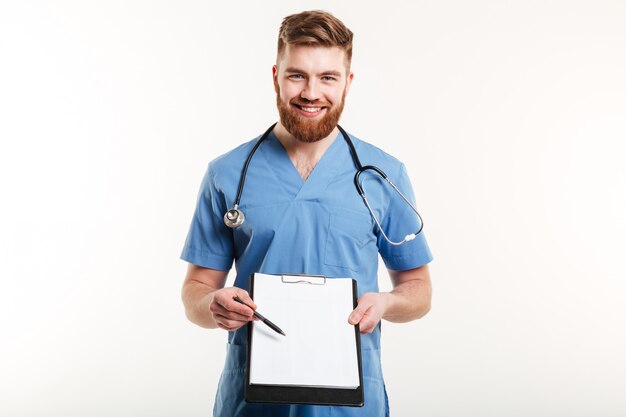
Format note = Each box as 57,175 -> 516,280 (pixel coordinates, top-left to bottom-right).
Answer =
245,273 -> 364,407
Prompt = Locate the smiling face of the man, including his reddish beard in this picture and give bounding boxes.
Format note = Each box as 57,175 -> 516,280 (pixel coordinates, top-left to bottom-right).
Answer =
273,45 -> 353,143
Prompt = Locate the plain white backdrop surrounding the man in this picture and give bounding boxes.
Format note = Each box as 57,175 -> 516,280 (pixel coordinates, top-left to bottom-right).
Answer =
0,0 -> 626,417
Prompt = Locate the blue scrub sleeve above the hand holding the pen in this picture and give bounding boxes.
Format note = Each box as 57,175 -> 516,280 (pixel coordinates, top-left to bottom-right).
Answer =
180,164 -> 234,271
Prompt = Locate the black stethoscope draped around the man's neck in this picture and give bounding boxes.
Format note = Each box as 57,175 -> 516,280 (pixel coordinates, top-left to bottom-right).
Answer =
224,123 -> 424,245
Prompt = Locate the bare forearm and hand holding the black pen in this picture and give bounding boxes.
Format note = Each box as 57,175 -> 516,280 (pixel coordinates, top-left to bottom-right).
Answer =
181,263 -> 256,330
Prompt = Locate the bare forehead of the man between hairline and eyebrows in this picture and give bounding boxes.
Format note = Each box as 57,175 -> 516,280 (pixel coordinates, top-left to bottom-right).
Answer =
277,44 -> 346,73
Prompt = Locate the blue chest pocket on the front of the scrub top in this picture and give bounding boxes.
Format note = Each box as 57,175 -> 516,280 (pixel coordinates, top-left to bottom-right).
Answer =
324,211 -> 374,272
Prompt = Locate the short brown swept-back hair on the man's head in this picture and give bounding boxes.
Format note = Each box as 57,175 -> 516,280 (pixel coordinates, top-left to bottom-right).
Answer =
277,10 -> 353,69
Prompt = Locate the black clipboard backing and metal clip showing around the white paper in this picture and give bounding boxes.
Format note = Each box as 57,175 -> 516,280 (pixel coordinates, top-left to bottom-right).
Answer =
244,274 -> 365,407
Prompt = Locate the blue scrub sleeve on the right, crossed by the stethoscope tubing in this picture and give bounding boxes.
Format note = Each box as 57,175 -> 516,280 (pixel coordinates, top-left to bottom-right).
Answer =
377,164 -> 433,271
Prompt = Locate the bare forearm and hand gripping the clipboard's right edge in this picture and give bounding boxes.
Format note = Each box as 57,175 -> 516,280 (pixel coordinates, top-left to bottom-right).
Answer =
348,265 -> 432,333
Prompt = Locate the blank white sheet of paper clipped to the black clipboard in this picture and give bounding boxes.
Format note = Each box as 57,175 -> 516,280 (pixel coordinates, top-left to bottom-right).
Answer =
250,274 -> 359,388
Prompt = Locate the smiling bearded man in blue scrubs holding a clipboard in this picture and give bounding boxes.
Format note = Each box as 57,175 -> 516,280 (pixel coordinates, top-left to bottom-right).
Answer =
181,11 -> 432,417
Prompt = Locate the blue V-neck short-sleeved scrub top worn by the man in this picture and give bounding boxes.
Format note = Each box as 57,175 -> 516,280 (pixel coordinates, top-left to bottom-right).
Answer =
181,128 -> 432,417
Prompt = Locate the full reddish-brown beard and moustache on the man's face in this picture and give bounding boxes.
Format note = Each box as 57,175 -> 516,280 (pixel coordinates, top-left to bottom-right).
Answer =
276,87 -> 346,143
